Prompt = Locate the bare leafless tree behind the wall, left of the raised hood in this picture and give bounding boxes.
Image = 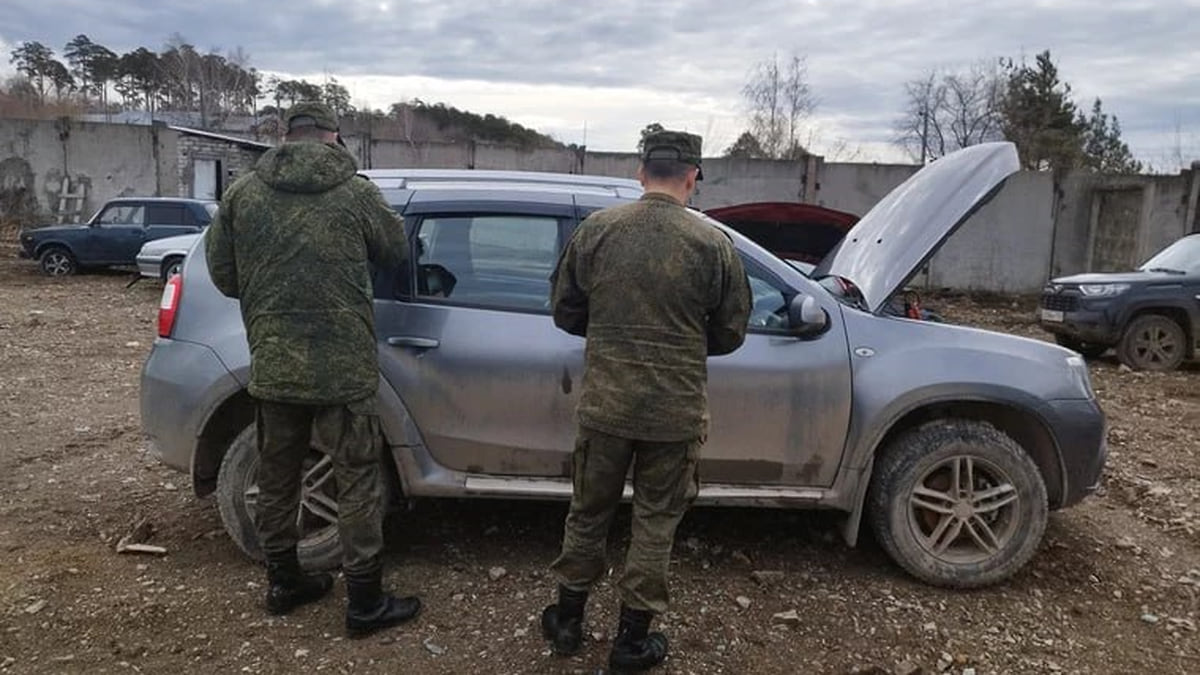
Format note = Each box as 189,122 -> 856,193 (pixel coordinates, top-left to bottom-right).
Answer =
742,54 -> 816,159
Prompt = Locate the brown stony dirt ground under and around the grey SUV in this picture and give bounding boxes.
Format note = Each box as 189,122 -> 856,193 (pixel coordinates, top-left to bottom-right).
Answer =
0,249 -> 1200,675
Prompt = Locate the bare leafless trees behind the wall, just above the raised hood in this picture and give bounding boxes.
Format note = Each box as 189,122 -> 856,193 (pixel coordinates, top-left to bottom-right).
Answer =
895,61 -> 1003,163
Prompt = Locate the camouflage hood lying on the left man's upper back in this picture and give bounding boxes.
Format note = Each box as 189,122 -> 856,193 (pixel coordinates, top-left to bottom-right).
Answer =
254,143 -> 358,193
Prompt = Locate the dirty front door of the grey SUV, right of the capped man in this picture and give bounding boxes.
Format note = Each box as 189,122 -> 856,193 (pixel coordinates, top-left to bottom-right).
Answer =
701,243 -> 851,488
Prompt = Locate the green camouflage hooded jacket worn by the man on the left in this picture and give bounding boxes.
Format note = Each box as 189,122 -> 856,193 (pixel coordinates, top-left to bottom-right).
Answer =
205,142 -> 408,405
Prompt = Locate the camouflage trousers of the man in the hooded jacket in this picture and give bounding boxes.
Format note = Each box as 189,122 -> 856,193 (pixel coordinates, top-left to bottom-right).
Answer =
254,396 -> 384,574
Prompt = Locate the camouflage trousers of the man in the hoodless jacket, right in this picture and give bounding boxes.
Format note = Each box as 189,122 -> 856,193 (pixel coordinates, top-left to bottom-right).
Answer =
551,428 -> 703,614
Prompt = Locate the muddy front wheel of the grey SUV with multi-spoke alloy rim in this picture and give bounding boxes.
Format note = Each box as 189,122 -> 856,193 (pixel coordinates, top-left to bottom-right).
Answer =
868,419 -> 1049,589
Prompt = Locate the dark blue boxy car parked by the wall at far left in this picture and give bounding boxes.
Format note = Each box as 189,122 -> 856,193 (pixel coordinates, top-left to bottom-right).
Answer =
18,197 -> 217,276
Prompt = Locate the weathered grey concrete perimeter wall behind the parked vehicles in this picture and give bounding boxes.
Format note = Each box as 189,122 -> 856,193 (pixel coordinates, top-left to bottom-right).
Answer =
0,120 -> 1200,292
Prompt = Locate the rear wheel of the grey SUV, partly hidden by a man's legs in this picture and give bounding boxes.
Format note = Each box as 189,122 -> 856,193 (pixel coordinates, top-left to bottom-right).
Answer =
216,424 -> 342,571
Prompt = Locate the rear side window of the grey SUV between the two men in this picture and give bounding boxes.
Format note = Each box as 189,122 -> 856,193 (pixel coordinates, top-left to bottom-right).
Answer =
414,215 -> 559,311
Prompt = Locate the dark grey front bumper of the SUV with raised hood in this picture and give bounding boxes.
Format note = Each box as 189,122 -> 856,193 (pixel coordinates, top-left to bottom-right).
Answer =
1048,400 -> 1109,508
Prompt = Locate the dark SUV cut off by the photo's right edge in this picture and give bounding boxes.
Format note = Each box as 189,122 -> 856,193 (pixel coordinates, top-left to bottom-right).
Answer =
1038,233 -> 1200,370
